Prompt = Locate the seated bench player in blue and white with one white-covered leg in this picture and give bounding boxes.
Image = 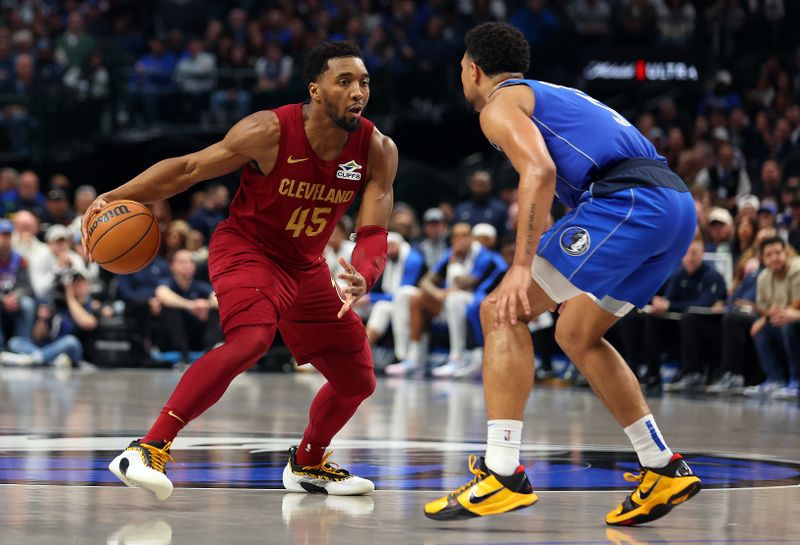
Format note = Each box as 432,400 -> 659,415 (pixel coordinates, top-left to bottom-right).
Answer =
386,223 -> 504,375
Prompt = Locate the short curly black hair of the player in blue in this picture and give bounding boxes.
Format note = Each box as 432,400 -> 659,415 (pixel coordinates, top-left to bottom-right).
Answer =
465,23 -> 531,76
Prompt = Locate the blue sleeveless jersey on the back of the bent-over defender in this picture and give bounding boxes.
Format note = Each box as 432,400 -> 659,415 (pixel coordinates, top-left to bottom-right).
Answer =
500,79 -> 666,208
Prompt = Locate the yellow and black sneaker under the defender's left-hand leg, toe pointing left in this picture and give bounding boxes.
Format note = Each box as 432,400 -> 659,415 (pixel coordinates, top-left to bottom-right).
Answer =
425,454 -> 539,520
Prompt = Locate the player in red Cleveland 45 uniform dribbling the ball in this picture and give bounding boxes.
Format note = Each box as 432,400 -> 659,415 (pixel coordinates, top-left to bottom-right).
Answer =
82,42 -> 397,500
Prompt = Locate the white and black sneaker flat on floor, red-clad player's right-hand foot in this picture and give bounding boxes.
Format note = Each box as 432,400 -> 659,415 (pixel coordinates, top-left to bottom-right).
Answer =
283,447 -> 375,496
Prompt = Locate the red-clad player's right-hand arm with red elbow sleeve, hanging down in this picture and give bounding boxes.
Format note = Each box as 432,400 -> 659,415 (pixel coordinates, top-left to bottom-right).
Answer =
338,129 -> 397,318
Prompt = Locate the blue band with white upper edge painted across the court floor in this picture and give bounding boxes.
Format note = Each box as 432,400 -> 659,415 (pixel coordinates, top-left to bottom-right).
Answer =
0,436 -> 800,491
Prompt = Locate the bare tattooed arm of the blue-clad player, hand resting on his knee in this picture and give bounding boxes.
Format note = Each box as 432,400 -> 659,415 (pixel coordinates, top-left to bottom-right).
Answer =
481,86 -> 556,325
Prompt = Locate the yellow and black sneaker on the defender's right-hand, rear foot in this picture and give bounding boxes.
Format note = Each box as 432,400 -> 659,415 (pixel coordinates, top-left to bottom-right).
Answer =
606,454 -> 703,526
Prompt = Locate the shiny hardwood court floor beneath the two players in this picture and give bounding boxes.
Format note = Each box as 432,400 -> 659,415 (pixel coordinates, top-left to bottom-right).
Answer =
0,369 -> 800,545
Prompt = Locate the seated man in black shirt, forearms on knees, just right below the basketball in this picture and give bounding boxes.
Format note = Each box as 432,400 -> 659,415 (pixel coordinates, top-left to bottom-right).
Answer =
156,250 -> 217,363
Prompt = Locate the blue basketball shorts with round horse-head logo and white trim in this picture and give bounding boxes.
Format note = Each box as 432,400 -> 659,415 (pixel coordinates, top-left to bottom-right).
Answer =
532,187 -> 697,316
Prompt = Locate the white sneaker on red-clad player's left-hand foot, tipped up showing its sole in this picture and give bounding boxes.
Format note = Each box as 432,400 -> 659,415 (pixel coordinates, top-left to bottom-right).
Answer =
108,439 -> 175,500
